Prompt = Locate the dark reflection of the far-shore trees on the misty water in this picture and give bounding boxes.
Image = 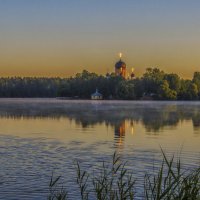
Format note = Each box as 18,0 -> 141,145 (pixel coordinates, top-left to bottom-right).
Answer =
0,101 -> 200,132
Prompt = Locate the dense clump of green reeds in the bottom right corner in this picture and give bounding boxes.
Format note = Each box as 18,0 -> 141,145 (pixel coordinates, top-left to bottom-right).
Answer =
144,150 -> 200,200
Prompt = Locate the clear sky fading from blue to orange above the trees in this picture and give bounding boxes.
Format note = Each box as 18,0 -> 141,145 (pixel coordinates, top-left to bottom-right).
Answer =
0,0 -> 200,78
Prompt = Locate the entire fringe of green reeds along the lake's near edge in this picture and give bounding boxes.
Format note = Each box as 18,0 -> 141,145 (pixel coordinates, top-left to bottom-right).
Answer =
48,149 -> 200,200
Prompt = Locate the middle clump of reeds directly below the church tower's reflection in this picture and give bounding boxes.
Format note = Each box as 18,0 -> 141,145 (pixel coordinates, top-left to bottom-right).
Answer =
92,153 -> 135,200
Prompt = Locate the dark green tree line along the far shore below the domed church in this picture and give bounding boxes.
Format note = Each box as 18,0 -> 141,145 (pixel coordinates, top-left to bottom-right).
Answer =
0,68 -> 200,100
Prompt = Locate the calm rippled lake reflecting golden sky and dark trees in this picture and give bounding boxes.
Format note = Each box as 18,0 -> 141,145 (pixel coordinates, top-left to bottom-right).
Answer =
0,99 -> 200,200
